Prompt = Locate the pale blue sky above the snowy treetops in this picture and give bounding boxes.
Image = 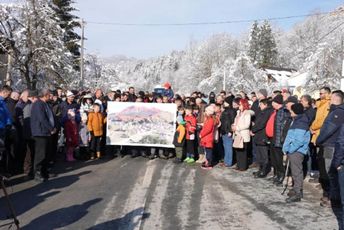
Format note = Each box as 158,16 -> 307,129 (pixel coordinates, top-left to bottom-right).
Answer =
0,0 -> 343,58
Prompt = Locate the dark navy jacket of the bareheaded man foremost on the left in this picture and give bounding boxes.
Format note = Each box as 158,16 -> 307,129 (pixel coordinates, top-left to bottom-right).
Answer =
30,99 -> 54,137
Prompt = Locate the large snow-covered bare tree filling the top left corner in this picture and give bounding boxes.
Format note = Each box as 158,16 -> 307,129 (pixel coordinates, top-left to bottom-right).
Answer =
0,0 -> 75,89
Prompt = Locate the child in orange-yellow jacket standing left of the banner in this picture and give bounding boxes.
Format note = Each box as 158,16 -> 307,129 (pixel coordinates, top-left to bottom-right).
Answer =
87,103 -> 105,159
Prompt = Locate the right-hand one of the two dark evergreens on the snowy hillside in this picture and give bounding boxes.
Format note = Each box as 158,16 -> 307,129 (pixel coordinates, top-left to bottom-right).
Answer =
258,21 -> 278,67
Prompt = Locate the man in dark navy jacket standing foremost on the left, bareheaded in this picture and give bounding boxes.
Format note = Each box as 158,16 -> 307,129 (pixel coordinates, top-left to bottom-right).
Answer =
31,89 -> 56,181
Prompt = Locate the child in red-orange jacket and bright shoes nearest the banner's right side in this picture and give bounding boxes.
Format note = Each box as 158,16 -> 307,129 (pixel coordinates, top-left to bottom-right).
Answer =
184,106 -> 197,164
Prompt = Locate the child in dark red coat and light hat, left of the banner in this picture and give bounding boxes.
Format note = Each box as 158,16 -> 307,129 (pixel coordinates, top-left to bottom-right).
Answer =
64,109 -> 79,161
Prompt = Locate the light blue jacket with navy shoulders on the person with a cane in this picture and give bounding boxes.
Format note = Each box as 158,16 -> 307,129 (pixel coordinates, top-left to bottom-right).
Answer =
283,114 -> 311,155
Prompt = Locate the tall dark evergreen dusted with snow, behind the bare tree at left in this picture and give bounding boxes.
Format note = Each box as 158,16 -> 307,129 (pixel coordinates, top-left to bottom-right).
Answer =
52,0 -> 81,70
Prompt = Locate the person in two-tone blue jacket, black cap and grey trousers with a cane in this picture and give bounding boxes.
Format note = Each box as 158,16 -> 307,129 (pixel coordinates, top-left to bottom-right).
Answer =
283,103 -> 311,203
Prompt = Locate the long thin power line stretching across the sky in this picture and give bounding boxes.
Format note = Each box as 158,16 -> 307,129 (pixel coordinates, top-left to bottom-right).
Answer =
87,12 -> 333,26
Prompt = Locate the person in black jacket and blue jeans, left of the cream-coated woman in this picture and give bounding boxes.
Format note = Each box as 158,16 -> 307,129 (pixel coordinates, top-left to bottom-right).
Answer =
220,97 -> 236,167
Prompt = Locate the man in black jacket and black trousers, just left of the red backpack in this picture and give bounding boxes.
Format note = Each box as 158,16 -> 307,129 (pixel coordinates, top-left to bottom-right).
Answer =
252,99 -> 273,178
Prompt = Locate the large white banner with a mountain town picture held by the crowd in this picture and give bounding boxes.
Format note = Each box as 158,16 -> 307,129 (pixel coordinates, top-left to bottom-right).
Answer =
106,102 -> 177,148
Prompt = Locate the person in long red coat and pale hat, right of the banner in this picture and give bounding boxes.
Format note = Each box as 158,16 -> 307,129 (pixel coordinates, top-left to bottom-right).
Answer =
199,105 -> 216,169
